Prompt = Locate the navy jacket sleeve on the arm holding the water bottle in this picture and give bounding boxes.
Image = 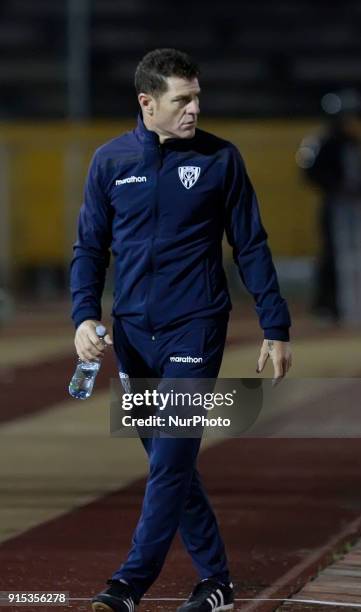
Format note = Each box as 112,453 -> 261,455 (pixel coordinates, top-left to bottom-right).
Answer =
70,152 -> 112,327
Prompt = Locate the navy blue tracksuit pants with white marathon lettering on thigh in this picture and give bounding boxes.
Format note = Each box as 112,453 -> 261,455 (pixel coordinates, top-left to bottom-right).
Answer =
112,315 -> 230,599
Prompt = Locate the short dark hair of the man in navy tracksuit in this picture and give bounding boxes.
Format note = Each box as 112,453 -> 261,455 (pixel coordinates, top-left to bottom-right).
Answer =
135,49 -> 200,97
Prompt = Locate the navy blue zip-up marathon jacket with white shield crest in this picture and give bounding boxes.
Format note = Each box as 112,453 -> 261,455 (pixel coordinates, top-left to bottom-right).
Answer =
70,117 -> 291,340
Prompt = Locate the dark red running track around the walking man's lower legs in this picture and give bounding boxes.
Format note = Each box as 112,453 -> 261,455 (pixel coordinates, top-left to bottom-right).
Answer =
0,438 -> 361,612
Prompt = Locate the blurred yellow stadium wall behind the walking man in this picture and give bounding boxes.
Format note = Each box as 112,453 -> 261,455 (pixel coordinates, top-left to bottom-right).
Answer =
0,119 -> 318,292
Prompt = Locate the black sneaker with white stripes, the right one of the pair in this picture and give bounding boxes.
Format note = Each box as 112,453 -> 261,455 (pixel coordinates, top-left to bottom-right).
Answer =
177,578 -> 234,612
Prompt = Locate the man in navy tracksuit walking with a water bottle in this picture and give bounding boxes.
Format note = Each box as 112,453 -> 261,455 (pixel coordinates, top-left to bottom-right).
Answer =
71,49 -> 291,612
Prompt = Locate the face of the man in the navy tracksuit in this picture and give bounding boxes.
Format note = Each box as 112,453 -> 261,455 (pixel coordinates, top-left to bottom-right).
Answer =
144,77 -> 200,138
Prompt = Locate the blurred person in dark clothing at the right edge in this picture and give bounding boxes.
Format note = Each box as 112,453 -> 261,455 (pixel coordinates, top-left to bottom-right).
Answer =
297,90 -> 361,323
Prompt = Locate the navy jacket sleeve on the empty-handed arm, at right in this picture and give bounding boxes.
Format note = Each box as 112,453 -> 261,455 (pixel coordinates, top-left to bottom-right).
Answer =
225,148 -> 291,341
